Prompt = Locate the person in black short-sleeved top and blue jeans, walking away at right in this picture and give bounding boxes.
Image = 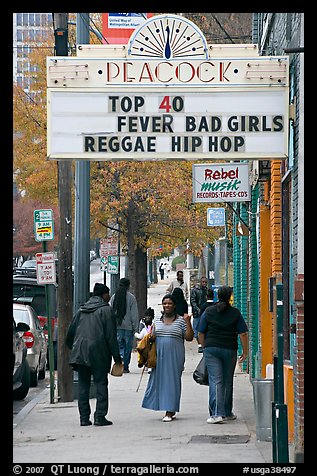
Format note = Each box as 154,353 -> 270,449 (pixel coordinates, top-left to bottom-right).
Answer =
198,286 -> 248,423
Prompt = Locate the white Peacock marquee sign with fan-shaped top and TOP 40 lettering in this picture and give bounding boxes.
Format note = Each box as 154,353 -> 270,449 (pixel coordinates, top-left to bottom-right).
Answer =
47,15 -> 288,161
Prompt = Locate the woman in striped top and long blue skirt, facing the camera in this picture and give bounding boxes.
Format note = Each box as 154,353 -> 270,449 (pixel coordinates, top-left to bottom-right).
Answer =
142,294 -> 194,422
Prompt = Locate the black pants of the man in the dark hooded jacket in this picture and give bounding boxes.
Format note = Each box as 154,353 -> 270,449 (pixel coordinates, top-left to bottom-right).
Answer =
77,365 -> 108,420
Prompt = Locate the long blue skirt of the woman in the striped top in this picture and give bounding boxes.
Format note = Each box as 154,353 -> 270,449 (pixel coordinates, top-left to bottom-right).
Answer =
142,337 -> 185,412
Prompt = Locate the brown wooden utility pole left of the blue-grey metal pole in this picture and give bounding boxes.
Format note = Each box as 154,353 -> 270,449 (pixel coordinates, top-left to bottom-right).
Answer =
53,13 -> 73,402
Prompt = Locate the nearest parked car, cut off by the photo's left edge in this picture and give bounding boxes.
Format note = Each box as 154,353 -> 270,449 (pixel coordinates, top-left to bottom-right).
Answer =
12,318 -> 30,400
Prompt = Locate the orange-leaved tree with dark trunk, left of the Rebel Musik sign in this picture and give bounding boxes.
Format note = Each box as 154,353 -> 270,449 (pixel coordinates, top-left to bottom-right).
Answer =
91,161 -> 219,309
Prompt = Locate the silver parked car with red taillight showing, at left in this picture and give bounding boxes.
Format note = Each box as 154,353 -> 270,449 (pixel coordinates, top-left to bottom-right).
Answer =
13,302 -> 47,387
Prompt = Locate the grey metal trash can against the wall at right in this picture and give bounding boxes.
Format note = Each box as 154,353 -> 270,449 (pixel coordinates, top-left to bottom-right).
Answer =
252,378 -> 274,441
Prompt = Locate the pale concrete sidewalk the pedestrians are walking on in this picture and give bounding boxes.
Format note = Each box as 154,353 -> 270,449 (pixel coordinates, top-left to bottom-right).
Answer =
13,276 -> 272,464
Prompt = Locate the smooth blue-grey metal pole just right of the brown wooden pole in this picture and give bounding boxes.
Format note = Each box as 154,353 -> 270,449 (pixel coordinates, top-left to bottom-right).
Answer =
73,13 -> 90,313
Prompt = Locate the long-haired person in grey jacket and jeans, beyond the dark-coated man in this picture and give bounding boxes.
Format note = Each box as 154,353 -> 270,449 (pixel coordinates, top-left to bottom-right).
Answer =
109,278 -> 139,373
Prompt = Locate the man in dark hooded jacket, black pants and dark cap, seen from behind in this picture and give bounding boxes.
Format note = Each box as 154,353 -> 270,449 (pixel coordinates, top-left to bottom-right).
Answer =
66,283 -> 122,426
